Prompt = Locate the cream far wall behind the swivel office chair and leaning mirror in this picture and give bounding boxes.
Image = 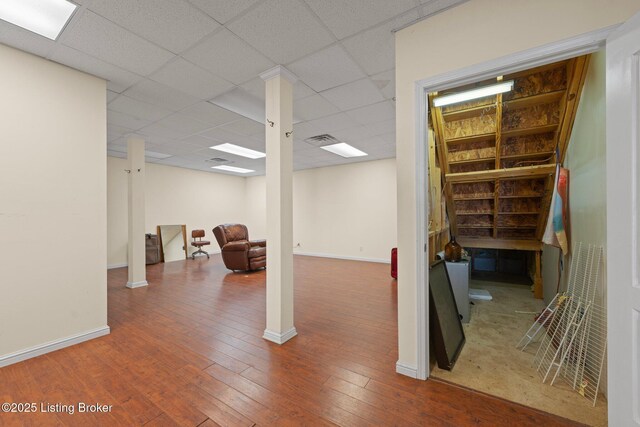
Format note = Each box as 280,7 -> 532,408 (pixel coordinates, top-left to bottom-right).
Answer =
107,157 -> 246,267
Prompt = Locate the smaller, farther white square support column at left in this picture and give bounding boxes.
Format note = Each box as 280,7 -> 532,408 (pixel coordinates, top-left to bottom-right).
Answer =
127,136 -> 148,288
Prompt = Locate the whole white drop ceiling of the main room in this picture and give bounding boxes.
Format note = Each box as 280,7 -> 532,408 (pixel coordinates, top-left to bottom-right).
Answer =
0,0 -> 465,176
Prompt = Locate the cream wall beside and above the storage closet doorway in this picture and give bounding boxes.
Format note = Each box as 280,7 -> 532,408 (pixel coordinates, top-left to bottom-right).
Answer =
396,0 -> 640,374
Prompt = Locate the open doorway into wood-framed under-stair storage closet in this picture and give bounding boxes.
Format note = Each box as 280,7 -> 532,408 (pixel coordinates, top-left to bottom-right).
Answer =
427,50 -> 607,425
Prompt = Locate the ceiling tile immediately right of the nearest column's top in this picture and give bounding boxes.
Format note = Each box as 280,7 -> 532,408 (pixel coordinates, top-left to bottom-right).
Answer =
288,44 -> 365,92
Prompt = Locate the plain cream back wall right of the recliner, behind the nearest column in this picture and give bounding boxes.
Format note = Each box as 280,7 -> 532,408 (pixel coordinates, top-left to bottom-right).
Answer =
247,159 -> 396,262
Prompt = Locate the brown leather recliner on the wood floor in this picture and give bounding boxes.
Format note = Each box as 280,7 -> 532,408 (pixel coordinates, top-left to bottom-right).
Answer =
213,224 -> 267,271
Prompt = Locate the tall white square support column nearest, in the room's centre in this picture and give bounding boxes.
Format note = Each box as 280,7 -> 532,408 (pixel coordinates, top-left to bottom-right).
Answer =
260,66 -> 297,344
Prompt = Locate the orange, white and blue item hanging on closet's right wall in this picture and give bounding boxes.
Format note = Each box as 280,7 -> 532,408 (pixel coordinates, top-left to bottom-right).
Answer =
542,164 -> 569,255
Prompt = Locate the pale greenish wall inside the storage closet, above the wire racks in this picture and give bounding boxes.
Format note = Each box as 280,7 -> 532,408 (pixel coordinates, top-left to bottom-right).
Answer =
542,50 -> 607,303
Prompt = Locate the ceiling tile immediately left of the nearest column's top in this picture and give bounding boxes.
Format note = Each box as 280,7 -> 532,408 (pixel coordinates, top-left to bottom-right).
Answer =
183,28 -> 275,84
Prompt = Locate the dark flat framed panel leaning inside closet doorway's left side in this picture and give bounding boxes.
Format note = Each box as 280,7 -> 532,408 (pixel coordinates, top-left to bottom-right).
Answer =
429,260 -> 465,371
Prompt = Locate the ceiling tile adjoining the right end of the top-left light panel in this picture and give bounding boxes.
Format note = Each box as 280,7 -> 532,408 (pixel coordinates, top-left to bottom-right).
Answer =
60,11 -> 173,75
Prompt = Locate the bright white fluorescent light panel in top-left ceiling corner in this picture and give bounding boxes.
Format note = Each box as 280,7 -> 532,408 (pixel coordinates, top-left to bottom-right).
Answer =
0,0 -> 78,40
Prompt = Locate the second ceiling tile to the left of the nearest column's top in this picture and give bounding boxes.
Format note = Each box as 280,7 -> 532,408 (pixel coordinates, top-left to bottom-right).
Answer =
149,58 -> 234,100
